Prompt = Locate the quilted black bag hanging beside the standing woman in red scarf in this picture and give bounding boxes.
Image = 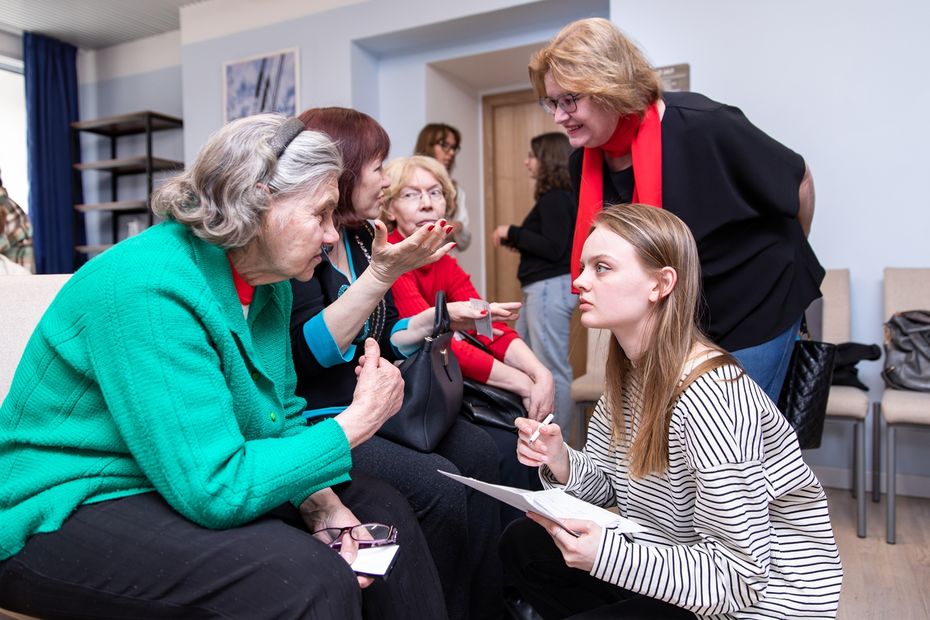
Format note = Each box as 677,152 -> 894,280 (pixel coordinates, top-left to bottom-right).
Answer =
778,322 -> 836,450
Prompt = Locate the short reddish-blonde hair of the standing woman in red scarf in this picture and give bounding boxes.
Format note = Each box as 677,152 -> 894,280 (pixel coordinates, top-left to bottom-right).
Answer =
528,17 -> 662,116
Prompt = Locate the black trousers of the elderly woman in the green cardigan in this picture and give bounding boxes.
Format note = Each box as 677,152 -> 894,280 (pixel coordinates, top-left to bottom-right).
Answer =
0,474 -> 445,620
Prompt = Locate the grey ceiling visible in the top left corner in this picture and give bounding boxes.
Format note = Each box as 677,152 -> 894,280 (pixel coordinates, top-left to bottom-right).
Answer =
0,0 -> 203,50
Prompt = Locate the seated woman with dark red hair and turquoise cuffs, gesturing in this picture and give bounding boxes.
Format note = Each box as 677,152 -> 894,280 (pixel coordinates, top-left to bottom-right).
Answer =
291,107 -> 508,619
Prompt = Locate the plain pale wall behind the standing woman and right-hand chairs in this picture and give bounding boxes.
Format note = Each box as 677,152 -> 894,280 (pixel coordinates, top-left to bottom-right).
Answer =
611,0 -> 930,494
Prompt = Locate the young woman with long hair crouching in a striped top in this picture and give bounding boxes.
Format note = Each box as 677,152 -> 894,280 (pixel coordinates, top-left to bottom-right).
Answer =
501,204 -> 842,619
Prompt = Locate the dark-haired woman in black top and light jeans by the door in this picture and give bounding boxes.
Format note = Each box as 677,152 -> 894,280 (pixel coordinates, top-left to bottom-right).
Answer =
493,132 -> 577,428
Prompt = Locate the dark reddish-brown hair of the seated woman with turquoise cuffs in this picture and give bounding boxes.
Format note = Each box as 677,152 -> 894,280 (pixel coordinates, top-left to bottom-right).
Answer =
298,107 -> 391,230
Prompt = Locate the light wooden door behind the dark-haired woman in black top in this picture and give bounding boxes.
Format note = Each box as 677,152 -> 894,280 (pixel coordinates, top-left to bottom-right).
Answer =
482,90 -> 587,376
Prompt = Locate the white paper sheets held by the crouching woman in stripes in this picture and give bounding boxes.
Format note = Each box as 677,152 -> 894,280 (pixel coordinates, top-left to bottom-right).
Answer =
437,469 -> 643,533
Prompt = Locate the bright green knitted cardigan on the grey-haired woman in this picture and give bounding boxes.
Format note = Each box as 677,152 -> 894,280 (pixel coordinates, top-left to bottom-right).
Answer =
0,221 -> 351,559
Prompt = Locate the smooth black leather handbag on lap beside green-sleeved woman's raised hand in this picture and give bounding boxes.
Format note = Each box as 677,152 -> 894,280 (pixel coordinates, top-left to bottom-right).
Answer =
378,291 -> 462,452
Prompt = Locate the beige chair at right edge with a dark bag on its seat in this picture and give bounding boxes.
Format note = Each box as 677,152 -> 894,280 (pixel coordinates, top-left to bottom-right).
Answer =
881,267 -> 930,544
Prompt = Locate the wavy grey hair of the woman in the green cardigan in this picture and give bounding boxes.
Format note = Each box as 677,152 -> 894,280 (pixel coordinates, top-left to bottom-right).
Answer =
152,114 -> 342,249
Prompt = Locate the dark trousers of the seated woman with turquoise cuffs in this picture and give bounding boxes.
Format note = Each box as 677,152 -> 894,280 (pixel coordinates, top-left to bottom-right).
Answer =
352,419 -> 504,620
